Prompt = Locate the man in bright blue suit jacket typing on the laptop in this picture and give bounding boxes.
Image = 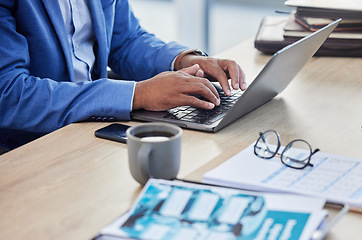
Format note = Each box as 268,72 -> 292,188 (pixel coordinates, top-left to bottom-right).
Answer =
0,0 -> 245,149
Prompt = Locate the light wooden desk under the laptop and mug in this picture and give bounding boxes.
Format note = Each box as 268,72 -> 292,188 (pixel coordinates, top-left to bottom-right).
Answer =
0,41 -> 362,240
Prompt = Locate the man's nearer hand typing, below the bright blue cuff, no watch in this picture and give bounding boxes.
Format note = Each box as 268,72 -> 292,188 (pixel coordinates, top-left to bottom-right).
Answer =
133,64 -> 220,111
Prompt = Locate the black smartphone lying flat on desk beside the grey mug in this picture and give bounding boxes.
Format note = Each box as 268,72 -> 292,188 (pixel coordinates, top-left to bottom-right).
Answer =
94,123 -> 130,143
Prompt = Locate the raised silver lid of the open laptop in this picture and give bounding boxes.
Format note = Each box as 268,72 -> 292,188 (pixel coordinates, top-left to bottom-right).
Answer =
214,19 -> 341,132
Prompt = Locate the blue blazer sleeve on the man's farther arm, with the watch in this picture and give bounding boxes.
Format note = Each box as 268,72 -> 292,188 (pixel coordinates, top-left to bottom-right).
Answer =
109,0 -> 189,80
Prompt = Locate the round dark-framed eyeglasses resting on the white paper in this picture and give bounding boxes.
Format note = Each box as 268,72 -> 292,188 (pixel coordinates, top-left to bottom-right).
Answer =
254,130 -> 319,169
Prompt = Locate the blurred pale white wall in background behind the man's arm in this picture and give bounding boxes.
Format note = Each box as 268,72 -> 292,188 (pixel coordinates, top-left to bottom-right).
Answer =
129,0 -> 291,54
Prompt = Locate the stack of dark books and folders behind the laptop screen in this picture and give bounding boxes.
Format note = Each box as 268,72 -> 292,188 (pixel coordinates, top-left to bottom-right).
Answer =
255,0 -> 362,57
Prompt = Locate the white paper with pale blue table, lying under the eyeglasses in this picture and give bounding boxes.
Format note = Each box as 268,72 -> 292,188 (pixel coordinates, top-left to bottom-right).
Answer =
203,144 -> 362,209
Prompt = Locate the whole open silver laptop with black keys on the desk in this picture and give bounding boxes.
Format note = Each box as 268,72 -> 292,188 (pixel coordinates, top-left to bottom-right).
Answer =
131,19 -> 341,132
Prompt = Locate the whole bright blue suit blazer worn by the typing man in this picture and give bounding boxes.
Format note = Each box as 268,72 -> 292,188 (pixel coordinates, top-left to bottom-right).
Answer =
0,0 -> 186,141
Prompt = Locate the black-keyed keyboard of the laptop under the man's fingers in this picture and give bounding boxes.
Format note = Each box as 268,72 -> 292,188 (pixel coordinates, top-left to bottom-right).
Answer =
164,87 -> 243,125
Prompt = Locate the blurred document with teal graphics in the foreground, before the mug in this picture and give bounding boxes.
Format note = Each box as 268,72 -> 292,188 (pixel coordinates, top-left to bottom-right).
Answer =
95,179 -> 348,240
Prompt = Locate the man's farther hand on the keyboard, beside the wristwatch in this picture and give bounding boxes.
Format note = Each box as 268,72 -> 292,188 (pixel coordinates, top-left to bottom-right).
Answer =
179,54 -> 246,96
